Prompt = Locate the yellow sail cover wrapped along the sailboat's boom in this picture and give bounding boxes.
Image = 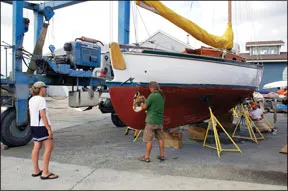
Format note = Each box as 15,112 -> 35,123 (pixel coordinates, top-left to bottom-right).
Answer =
136,1 -> 233,50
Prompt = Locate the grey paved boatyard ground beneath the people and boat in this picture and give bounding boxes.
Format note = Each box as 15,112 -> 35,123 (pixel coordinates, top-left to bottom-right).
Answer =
1,98 -> 287,190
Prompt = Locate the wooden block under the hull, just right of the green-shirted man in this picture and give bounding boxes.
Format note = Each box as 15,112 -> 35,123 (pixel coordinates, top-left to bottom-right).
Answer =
163,131 -> 183,149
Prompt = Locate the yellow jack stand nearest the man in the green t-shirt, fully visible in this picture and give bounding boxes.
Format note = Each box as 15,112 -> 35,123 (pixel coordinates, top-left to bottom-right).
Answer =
203,106 -> 242,158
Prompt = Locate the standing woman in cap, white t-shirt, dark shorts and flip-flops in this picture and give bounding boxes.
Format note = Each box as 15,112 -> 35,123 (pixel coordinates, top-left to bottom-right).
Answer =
29,81 -> 58,180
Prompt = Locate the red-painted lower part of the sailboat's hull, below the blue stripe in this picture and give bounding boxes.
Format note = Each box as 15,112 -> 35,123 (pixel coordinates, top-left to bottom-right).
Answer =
110,86 -> 254,129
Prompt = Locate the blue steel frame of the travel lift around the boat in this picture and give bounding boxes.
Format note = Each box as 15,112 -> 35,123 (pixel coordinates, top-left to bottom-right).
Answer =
1,0 -> 130,126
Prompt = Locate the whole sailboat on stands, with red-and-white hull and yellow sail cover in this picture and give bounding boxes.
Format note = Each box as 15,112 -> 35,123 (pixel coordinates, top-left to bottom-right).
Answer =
107,1 -> 263,129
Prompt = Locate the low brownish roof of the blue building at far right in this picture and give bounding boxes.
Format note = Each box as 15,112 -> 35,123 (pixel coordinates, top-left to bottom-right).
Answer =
240,52 -> 287,62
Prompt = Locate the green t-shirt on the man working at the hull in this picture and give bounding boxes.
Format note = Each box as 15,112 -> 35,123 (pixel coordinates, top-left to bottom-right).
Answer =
145,91 -> 164,125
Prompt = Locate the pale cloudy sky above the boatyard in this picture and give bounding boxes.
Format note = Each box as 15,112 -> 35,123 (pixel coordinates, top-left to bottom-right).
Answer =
1,1 -> 287,74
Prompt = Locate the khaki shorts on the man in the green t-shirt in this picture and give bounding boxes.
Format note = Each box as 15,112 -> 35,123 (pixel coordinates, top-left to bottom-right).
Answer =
143,123 -> 163,142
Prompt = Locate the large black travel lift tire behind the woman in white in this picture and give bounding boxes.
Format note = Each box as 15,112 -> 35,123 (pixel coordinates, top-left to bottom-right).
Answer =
1,108 -> 32,147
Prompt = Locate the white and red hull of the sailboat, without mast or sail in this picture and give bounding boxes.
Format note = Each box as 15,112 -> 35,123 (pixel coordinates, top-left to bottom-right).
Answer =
107,52 -> 263,129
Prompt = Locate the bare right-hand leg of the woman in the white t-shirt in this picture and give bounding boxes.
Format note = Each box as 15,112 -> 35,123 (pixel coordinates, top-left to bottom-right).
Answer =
42,139 -> 54,177
